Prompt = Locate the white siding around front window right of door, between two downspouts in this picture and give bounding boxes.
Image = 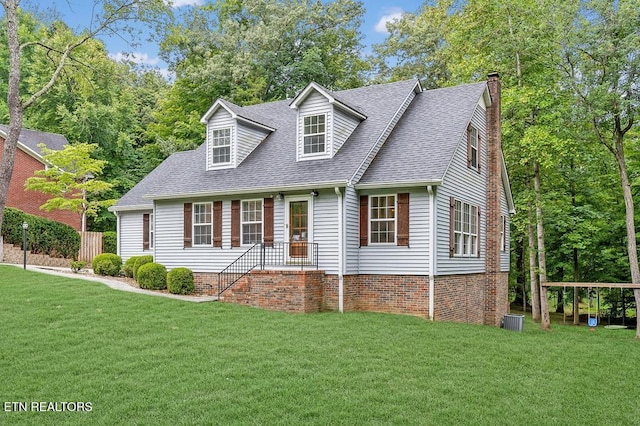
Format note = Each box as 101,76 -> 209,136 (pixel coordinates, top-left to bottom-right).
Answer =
356,188 -> 429,275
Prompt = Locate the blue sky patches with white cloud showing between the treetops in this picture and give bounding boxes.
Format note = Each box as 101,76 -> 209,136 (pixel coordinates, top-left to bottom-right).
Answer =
45,0 -> 423,76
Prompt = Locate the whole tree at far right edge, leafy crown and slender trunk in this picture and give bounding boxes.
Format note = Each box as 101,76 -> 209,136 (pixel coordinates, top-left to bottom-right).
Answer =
559,0 -> 640,338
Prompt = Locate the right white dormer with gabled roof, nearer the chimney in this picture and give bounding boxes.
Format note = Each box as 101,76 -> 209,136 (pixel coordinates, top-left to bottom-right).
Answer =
290,83 -> 367,161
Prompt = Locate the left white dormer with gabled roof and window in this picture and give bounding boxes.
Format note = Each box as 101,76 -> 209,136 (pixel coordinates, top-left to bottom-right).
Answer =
200,99 -> 275,170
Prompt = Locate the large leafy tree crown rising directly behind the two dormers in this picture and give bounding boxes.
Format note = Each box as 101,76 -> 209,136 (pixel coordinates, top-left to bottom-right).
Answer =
150,0 -> 365,154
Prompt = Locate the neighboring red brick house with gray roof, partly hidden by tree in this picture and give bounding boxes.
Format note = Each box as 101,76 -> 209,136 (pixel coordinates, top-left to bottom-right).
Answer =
0,124 -> 81,231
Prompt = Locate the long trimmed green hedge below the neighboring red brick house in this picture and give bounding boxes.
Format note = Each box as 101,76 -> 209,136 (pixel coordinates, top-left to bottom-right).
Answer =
2,207 -> 80,259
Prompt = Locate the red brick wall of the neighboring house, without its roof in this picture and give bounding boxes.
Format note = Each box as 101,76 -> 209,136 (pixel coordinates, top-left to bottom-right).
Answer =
0,138 -> 81,231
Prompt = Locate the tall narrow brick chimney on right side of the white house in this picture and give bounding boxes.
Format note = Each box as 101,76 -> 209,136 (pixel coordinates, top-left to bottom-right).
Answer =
483,73 -> 509,326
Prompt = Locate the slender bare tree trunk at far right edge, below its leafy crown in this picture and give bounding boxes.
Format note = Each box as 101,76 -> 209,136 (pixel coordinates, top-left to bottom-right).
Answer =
614,145 -> 640,339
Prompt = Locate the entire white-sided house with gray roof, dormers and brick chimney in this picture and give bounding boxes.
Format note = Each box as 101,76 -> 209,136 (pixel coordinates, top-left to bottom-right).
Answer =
111,74 -> 514,325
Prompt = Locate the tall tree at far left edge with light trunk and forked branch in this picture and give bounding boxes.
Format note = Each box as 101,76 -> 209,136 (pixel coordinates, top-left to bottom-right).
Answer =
0,0 -> 167,245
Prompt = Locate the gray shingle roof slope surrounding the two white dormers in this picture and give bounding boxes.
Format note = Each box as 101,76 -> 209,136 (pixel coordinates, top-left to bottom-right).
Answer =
114,80 -> 418,210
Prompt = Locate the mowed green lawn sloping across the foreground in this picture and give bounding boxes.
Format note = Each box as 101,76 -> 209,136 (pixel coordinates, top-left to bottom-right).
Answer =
0,266 -> 640,425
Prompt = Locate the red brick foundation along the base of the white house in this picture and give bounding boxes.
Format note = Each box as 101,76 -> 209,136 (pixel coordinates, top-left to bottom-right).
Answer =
194,271 -> 508,326
